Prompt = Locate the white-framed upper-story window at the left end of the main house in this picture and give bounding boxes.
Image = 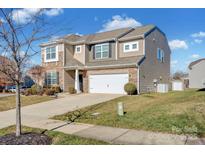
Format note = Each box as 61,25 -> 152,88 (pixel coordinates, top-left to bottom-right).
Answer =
45,46 -> 58,62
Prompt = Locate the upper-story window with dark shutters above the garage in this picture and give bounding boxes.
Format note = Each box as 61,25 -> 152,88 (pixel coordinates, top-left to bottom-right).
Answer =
95,43 -> 109,59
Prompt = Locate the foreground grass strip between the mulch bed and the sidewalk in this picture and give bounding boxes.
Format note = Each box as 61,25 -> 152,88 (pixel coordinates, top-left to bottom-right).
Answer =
0,126 -> 108,145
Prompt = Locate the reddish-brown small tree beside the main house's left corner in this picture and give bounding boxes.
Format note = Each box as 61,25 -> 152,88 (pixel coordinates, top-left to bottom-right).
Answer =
28,65 -> 45,85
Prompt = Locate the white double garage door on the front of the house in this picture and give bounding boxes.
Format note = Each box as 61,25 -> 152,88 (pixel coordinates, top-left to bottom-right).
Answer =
89,74 -> 129,94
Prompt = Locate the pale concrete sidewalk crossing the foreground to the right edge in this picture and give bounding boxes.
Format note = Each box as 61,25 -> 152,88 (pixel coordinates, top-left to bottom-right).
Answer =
24,120 -> 205,145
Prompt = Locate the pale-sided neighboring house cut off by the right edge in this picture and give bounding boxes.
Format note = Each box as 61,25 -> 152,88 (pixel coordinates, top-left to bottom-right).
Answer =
189,58 -> 205,88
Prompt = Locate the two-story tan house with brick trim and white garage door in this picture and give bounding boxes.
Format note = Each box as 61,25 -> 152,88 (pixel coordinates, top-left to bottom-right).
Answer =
40,25 -> 171,94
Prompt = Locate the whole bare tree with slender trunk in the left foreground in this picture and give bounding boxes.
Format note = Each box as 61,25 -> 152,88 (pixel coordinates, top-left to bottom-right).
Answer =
0,9 -> 64,136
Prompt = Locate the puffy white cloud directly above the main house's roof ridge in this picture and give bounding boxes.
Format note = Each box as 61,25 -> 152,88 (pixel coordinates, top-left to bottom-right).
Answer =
99,15 -> 142,32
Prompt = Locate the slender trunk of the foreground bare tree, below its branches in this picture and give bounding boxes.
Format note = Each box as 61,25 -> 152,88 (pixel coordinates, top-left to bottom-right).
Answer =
16,83 -> 21,137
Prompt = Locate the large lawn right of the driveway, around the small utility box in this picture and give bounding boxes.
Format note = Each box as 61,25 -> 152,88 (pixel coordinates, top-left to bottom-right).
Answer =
53,90 -> 205,137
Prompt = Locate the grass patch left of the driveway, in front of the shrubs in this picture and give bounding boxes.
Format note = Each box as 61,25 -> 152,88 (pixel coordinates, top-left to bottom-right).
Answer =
0,95 -> 54,111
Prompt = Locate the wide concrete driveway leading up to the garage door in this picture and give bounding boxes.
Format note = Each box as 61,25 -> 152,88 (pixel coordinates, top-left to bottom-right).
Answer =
0,94 -> 122,128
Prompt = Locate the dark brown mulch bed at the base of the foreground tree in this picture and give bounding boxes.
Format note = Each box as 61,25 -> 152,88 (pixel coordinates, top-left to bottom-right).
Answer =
0,132 -> 52,145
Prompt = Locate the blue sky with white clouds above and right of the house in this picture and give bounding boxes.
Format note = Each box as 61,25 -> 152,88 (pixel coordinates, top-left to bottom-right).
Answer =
6,9 -> 205,72
